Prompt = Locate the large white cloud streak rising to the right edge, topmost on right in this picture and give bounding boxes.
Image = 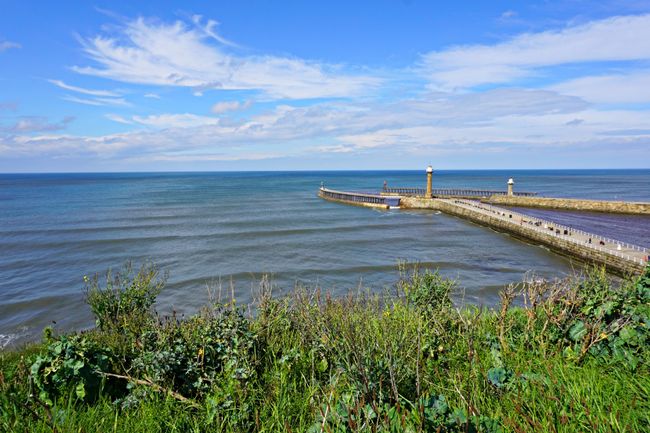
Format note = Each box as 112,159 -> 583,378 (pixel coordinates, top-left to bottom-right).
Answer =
422,15 -> 650,89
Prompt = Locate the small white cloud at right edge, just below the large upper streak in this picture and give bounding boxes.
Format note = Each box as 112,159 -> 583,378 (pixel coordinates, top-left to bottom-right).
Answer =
551,70 -> 650,104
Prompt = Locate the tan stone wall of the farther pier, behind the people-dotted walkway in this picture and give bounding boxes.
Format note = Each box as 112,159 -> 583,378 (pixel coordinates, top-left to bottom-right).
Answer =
481,195 -> 650,215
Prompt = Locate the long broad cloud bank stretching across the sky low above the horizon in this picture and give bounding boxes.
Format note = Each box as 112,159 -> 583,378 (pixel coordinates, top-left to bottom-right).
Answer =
0,89 -> 616,160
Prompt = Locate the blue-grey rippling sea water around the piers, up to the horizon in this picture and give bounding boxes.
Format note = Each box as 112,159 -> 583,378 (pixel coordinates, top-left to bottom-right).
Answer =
0,170 -> 650,347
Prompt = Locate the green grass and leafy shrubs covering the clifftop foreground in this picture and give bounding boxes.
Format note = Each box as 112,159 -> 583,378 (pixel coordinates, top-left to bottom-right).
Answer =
0,266 -> 650,433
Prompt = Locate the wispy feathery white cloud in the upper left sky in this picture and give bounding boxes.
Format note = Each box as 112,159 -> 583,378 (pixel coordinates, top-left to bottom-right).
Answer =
73,18 -> 379,98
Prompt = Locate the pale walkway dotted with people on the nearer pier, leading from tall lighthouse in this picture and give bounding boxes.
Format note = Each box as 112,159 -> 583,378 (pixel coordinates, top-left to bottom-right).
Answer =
438,199 -> 650,268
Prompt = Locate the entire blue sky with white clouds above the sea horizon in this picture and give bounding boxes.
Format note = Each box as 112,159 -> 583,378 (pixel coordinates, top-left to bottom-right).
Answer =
0,0 -> 650,173
